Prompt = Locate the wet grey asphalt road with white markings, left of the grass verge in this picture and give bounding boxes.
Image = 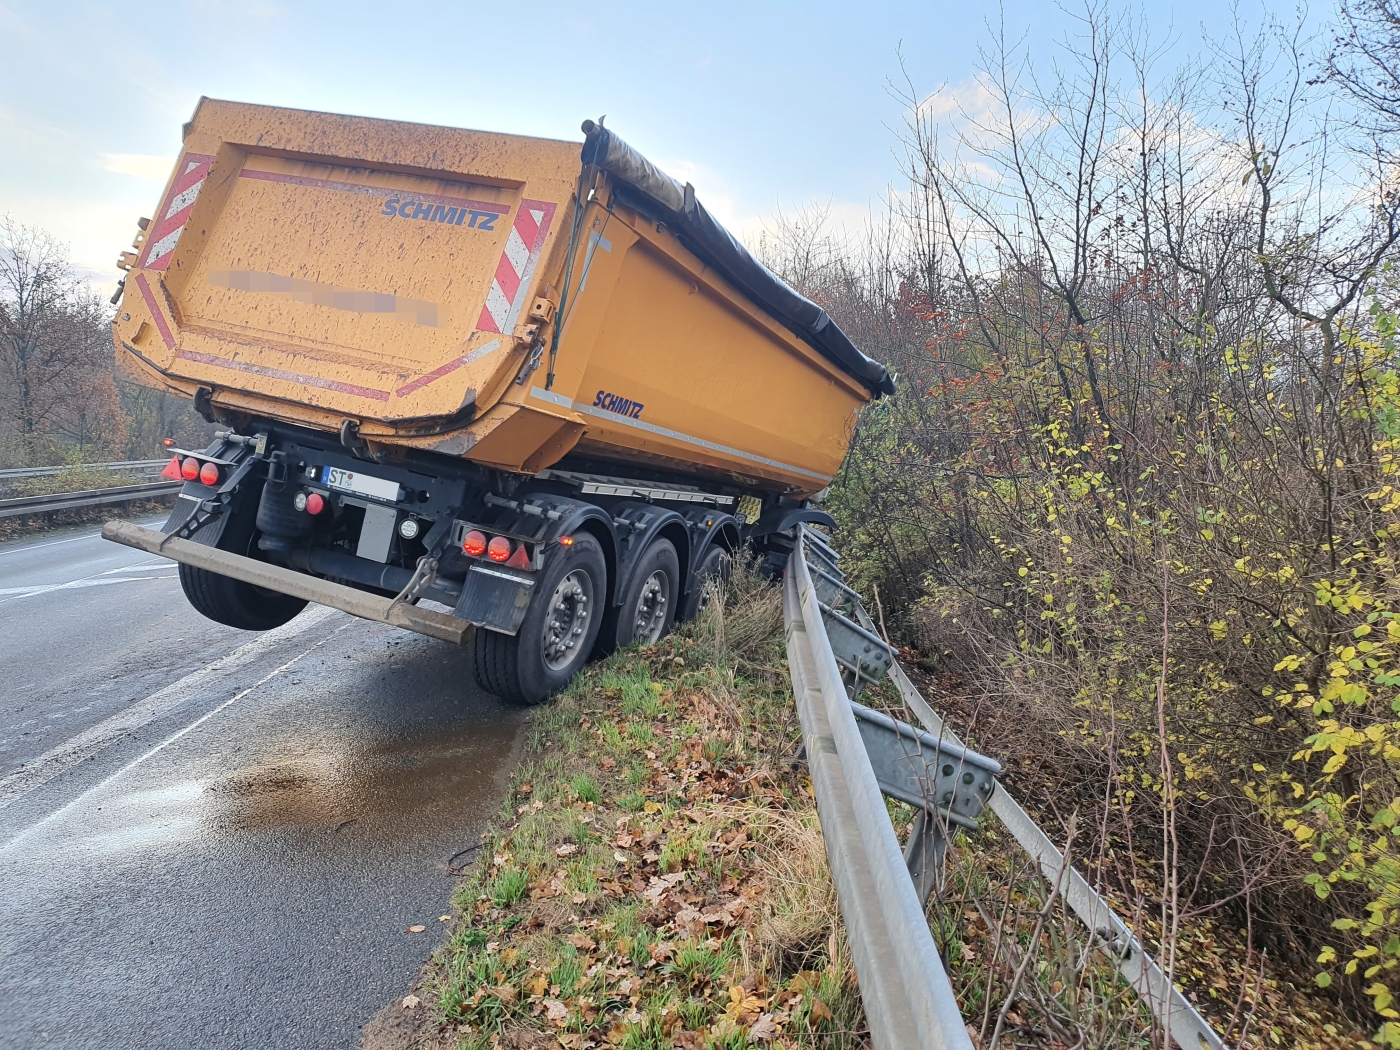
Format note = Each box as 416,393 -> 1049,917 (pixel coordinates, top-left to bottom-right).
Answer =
0,531 -> 524,1049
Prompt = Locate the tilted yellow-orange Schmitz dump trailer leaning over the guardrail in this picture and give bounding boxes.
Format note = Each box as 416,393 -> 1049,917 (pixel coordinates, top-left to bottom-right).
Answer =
109,99 -> 893,700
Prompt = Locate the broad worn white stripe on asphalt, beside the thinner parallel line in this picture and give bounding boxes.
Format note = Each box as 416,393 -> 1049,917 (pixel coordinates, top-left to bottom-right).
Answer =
0,605 -> 337,809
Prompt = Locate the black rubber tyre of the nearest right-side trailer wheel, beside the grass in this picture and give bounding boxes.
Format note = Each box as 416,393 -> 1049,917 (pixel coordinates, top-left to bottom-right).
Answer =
472,532 -> 608,704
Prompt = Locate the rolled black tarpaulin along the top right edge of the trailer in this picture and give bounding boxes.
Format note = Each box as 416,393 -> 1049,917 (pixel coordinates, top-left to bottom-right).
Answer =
582,120 -> 895,396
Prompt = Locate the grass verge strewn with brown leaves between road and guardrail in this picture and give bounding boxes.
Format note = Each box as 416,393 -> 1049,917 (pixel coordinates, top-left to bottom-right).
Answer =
367,574 -> 864,1050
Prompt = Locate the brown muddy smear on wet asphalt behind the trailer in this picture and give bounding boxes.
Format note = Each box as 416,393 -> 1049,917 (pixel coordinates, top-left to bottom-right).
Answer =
206,718 -> 519,832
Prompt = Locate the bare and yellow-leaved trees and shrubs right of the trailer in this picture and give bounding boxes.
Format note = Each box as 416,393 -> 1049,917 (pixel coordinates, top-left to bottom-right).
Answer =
762,0 -> 1400,1046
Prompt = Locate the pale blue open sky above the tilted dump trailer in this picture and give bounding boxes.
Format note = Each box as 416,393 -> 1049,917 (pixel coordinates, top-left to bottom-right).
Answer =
0,0 -> 1310,286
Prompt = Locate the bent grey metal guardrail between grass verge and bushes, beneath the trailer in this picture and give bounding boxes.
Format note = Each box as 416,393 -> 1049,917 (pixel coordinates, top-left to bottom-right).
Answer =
783,526 -> 1224,1050
